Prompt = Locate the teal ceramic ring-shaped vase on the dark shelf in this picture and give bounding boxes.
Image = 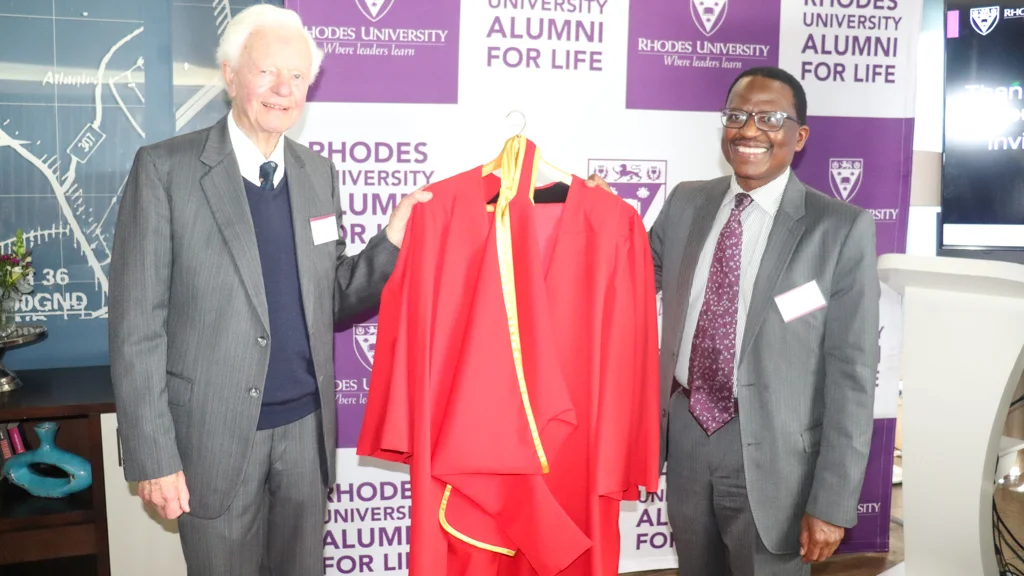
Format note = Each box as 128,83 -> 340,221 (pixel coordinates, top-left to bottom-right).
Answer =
3,422 -> 92,498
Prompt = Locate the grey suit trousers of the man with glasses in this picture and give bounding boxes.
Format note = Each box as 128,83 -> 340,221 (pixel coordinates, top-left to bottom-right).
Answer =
666,389 -> 811,576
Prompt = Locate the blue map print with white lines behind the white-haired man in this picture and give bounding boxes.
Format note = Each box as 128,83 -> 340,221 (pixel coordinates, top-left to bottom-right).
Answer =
0,0 -> 264,364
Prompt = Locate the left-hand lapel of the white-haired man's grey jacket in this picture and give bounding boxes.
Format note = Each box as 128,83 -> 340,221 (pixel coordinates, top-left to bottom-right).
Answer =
200,116 -> 270,332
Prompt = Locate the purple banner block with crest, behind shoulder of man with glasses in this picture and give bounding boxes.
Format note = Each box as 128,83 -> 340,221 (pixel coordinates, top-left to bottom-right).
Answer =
794,116 -> 913,254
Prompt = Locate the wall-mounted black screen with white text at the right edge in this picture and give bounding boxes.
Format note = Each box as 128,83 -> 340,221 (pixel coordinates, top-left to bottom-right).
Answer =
941,0 -> 1024,250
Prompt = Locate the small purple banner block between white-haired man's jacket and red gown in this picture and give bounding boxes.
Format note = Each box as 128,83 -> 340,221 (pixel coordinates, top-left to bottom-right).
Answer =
334,317 -> 377,448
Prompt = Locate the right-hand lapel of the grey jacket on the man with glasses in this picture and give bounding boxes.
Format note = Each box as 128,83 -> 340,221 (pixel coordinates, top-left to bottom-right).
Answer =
739,174 -> 806,362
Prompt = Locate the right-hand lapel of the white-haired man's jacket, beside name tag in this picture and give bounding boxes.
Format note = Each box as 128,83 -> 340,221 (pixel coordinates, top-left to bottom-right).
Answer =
282,136 -> 319,354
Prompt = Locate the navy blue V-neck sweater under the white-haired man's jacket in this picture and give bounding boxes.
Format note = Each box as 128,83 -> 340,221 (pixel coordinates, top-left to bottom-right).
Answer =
243,174 -> 319,429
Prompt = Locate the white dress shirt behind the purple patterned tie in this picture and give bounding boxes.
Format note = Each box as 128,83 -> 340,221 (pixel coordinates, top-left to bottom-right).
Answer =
676,168 -> 791,394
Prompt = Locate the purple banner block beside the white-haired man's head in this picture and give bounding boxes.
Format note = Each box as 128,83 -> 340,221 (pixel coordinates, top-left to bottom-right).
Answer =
285,0 -> 460,104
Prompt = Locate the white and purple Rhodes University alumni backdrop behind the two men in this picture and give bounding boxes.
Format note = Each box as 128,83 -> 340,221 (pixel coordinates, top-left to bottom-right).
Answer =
286,0 -> 921,575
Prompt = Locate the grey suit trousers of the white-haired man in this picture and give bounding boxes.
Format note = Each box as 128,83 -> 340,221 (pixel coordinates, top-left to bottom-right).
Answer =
178,411 -> 327,576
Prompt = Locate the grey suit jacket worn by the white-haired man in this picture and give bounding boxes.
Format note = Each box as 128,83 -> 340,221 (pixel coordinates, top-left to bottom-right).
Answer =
110,117 -> 398,518
